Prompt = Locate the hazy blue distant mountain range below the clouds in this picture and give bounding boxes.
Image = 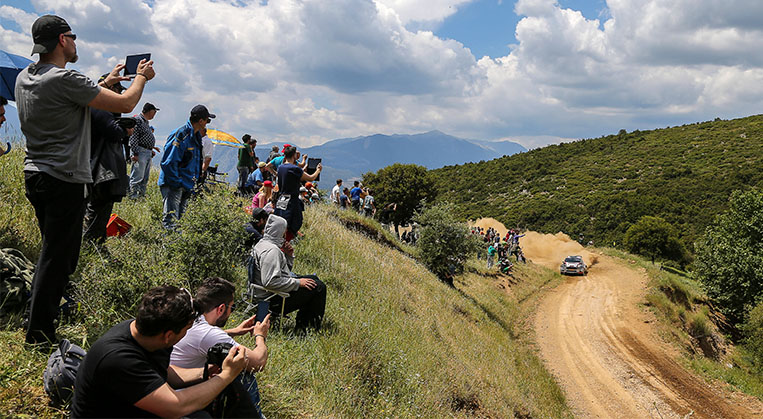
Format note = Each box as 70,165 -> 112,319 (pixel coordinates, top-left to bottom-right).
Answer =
207,131 -> 527,188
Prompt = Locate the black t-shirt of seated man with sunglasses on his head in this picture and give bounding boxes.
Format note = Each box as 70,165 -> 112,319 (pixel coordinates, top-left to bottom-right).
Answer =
71,320 -> 172,418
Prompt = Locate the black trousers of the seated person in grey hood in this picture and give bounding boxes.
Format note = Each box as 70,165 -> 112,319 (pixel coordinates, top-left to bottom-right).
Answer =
270,275 -> 326,330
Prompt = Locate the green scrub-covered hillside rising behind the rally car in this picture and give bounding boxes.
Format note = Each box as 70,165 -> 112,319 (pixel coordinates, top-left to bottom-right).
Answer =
432,115 -> 763,250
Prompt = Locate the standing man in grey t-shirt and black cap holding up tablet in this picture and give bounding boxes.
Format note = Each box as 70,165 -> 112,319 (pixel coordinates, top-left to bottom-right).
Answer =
15,15 -> 155,343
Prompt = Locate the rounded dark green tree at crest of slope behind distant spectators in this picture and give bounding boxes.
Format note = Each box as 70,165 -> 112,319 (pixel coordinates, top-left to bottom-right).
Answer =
363,163 -> 436,231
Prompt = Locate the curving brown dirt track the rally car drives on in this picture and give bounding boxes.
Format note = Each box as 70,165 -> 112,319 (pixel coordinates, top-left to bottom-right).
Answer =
478,220 -> 763,419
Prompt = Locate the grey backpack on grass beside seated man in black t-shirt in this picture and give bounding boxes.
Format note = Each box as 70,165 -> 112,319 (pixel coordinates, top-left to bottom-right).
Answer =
42,339 -> 87,407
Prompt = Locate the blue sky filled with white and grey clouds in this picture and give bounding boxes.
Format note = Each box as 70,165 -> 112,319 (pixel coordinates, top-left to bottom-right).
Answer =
0,0 -> 763,148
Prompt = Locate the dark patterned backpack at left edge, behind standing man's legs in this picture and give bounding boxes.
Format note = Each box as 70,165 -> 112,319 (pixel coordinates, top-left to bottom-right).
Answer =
0,248 -> 34,315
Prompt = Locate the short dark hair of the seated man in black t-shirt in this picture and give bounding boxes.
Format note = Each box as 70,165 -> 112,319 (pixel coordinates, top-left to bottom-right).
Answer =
135,285 -> 197,336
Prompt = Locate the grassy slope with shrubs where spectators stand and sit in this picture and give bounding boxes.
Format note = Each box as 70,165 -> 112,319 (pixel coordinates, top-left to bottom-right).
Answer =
0,149 -> 569,417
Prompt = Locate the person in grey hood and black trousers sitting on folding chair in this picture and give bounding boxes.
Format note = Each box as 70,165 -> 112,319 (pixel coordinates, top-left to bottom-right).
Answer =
250,215 -> 326,330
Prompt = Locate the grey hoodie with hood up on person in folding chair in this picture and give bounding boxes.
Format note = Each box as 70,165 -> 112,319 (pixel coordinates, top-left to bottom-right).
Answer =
252,214 -> 299,300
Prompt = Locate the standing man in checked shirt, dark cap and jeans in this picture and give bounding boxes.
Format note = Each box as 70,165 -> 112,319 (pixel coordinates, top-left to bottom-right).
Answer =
130,102 -> 159,199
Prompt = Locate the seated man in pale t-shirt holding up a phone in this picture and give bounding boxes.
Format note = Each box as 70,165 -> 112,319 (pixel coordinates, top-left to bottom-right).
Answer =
170,278 -> 270,418
